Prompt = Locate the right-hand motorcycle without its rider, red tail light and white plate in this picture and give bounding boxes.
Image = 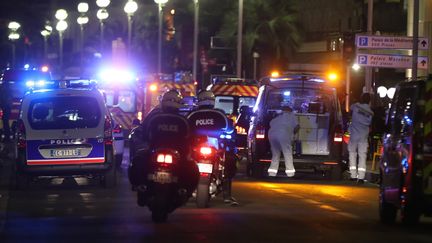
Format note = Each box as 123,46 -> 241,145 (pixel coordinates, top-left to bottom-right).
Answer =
193,134 -> 231,208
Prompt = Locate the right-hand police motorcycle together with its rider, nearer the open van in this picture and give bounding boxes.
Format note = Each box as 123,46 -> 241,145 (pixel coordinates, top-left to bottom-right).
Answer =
188,91 -> 234,208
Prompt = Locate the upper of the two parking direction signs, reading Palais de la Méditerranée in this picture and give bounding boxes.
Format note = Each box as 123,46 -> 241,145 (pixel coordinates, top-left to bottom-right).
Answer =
356,35 -> 429,50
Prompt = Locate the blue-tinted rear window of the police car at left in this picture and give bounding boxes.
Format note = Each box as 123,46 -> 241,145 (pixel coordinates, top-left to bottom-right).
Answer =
28,96 -> 101,130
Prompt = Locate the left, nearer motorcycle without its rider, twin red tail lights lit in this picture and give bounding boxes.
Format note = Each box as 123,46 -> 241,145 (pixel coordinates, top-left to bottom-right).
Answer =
136,148 -> 190,223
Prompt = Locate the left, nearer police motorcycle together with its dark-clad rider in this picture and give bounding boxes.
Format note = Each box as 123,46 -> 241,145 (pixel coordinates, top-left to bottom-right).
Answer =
128,91 -> 199,223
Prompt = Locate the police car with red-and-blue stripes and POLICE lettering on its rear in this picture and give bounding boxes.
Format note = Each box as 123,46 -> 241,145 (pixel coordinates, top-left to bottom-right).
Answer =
16,80 -> 116,188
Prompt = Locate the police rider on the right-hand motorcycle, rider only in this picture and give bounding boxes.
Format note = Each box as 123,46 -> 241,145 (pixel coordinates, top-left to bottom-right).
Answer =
188,90 -> 238,206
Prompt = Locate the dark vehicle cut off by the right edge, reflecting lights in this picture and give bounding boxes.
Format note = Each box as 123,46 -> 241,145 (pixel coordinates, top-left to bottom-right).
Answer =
379,79 -> 432,224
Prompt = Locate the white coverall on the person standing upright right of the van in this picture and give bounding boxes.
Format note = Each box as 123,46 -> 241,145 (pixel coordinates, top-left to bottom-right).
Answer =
348,103 -> 374,180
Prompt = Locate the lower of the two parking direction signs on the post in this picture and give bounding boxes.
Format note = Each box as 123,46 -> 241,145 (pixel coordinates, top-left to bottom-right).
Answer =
357,54 -> 428,69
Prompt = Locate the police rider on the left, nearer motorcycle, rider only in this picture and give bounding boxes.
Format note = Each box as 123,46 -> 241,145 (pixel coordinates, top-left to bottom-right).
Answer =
128,90 -> 199,206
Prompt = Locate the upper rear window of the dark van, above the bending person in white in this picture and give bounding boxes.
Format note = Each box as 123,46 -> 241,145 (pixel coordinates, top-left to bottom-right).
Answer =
266,88 -> 336,114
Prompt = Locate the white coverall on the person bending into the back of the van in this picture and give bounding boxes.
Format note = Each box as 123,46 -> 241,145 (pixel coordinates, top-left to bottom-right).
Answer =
268,111 -> 298,177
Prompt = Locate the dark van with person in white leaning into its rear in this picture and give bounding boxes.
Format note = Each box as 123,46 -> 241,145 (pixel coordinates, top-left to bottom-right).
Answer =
247,73 -> 346,179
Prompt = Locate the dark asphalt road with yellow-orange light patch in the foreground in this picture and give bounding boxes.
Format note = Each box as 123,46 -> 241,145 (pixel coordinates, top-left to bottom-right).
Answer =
0,151 -> 432,243
